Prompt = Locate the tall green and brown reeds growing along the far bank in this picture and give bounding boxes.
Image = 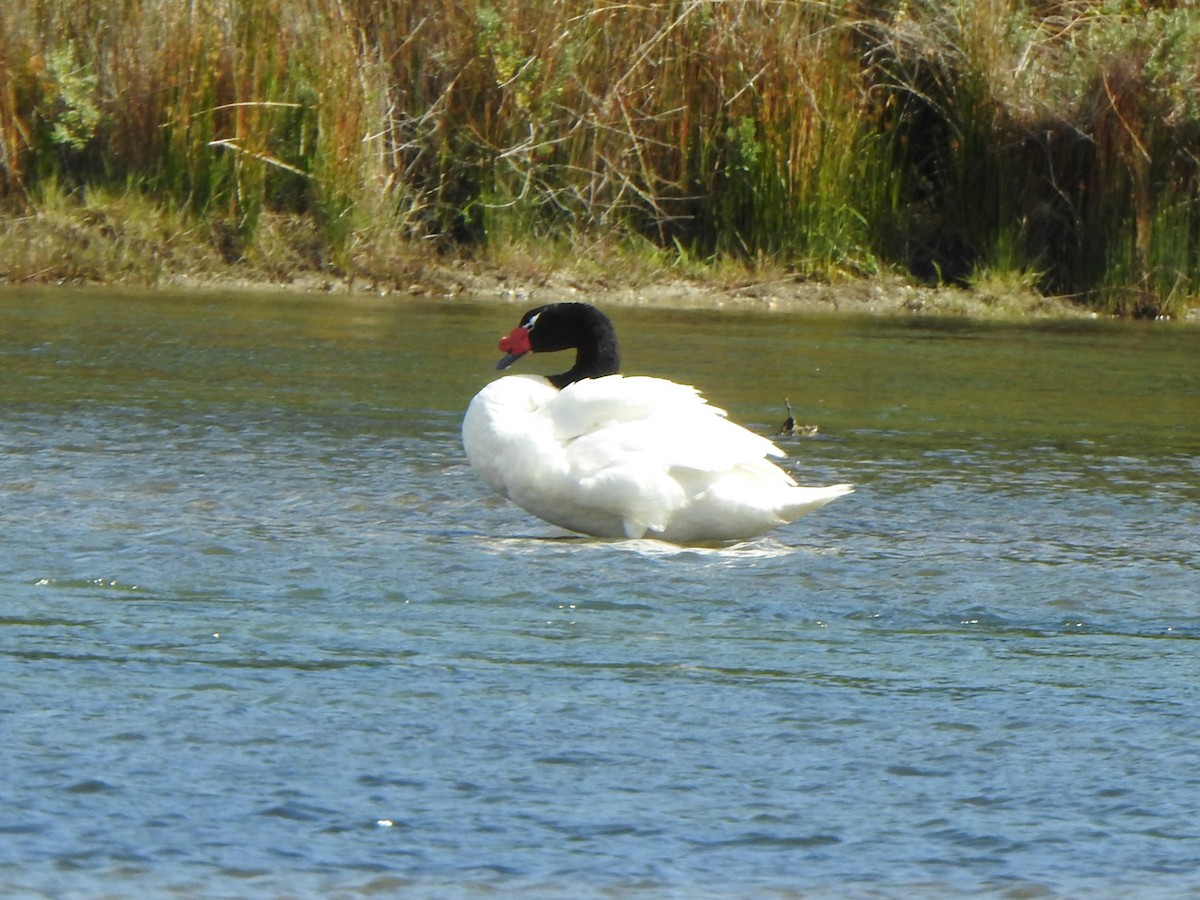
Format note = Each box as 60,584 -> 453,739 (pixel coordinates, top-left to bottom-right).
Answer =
0,0 -> 1200,314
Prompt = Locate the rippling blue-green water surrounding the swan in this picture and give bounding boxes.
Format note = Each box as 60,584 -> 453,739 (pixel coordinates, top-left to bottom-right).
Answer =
0,289 -> 1200,898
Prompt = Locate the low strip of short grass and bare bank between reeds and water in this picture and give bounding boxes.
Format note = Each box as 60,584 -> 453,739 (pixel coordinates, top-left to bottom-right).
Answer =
0,205 -> 1200,322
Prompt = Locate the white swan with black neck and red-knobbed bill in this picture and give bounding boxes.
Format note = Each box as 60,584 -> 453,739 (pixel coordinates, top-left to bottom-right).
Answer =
462,302 -> 853,544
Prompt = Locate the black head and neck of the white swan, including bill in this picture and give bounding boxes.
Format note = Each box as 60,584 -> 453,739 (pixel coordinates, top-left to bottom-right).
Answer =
496,304 -> 620,388
